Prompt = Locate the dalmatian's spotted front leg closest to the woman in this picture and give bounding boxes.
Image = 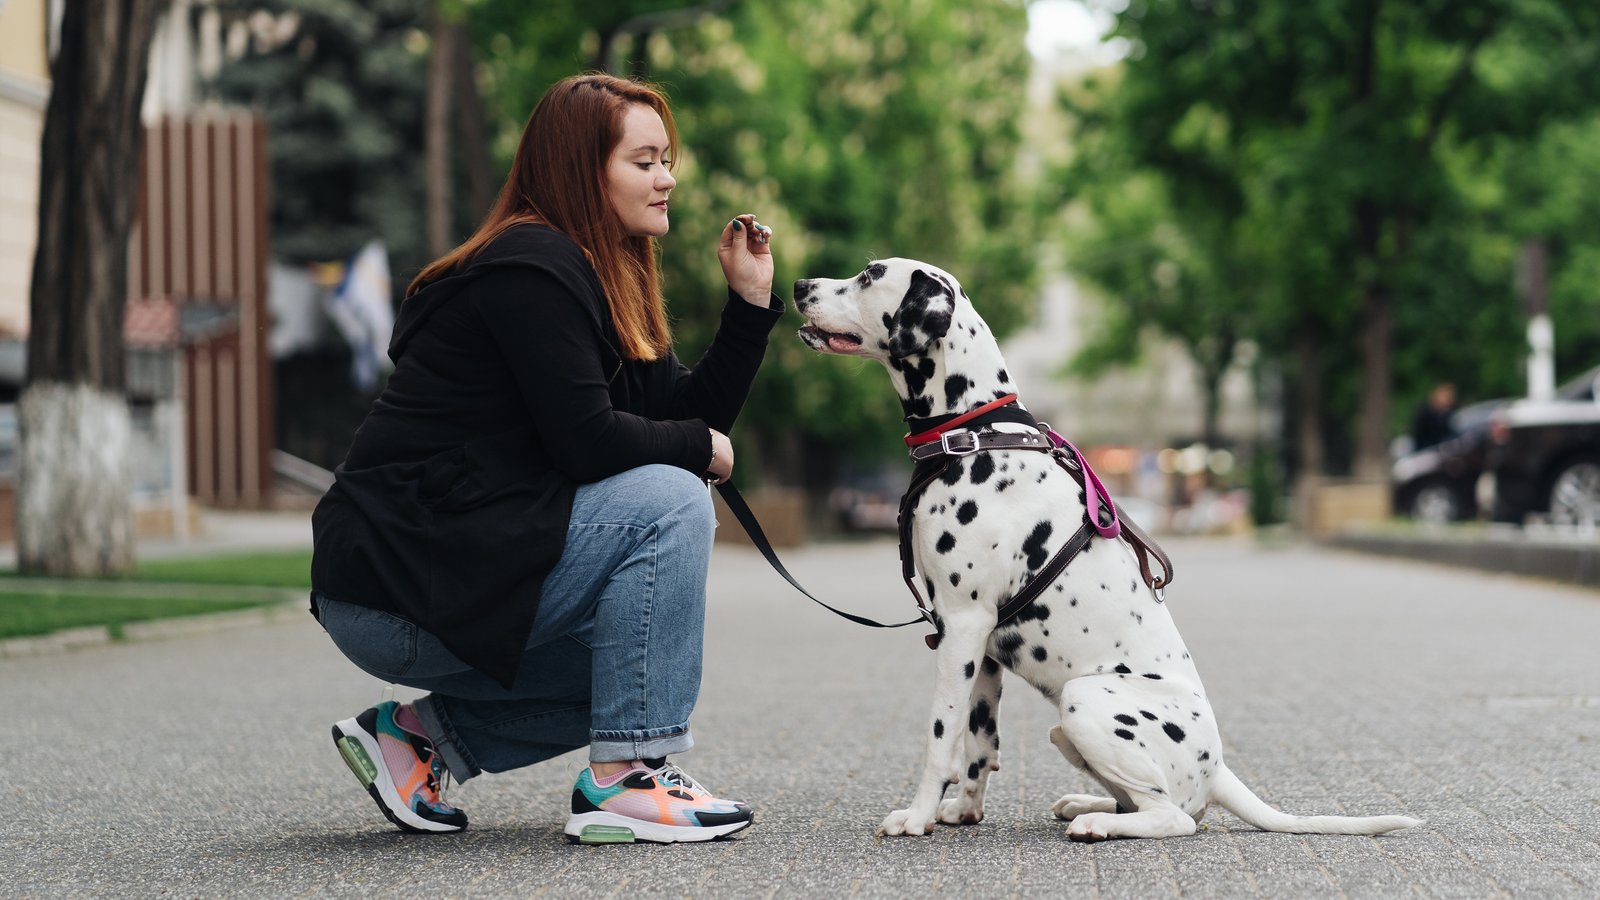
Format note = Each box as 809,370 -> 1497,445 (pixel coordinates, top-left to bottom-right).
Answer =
878,607 -> 995,836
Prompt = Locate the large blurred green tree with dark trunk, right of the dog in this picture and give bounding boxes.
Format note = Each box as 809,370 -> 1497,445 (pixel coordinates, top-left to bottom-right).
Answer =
1056,0 -> 1600,477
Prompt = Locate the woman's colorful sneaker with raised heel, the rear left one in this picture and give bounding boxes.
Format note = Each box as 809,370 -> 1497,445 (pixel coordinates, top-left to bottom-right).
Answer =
333,700 -> 467,834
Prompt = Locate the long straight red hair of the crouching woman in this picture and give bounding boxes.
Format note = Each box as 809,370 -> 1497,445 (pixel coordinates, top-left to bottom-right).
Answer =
406,74 -> 678,360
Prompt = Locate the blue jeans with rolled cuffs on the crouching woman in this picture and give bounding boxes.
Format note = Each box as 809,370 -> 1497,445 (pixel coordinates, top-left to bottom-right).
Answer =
318,466 -> 715,781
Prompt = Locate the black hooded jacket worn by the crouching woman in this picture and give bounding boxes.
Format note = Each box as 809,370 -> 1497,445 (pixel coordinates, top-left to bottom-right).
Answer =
312,226 -> 782,685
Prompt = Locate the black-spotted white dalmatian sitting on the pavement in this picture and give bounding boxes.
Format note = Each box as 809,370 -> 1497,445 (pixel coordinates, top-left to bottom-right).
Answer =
794,259 -> 1421,841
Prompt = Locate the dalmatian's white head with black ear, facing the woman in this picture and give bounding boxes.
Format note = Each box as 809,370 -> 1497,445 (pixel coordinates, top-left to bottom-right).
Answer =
795,258 -> 962,364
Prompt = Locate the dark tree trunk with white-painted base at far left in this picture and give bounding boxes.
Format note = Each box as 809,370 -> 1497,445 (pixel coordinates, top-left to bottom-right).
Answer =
16,0 -> 166,575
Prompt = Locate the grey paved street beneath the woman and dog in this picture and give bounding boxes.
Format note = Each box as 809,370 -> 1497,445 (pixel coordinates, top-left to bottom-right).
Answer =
0,541 -> 1600,898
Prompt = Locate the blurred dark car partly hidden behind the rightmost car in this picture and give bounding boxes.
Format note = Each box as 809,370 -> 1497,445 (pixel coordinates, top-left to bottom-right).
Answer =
1389,400 -> 1510,522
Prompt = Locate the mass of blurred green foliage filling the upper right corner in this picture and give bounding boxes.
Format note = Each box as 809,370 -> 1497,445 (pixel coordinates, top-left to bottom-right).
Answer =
1061,0 -> 1600,474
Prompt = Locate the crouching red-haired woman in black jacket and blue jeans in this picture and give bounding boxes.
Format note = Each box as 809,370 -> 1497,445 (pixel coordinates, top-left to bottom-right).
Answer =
312,75 -> 782,842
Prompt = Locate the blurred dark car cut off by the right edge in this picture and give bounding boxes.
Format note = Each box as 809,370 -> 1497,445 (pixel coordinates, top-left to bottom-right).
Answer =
1482,360 -> 1600,527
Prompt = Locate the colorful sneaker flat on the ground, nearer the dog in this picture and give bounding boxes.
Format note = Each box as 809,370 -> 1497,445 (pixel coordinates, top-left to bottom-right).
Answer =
566,764 -> 755,844
